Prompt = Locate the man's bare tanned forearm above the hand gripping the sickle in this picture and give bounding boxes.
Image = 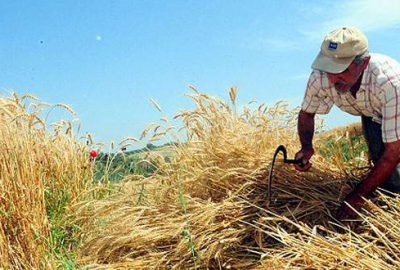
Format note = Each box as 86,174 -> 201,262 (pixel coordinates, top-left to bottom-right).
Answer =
297,110 -> 315,149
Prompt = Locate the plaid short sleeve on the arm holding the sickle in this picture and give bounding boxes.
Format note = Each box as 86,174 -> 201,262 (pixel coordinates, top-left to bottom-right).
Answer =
301,71 -> 333,114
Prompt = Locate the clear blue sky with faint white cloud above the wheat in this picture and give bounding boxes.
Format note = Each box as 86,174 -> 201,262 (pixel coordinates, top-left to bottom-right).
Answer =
0,0 -> 400,148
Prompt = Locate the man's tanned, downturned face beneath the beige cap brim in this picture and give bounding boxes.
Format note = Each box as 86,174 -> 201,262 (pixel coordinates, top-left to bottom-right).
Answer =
327,59 -> 365,93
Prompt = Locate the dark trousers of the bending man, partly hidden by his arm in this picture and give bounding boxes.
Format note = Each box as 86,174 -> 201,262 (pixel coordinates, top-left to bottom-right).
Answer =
361,116 -> 400,193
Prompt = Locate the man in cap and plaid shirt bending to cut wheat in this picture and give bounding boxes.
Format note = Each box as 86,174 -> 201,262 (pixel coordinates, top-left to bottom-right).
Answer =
295,27 -> 400,220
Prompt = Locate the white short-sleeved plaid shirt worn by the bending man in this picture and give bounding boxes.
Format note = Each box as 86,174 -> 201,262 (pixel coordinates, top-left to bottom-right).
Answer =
301,53 -> 400,143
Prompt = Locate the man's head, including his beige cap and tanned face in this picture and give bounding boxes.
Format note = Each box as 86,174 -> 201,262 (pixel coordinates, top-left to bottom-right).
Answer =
312,27 -> 370,91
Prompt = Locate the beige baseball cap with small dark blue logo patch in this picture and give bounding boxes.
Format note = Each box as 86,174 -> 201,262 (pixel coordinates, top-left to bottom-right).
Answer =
311,27 -> 368,74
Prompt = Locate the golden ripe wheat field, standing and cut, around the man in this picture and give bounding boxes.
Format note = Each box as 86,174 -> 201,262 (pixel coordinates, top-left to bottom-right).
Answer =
0,88 -> 400,269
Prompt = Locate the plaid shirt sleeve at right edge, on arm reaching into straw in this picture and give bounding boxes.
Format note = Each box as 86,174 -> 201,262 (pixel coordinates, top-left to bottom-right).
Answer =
381,80 -> 400,143
